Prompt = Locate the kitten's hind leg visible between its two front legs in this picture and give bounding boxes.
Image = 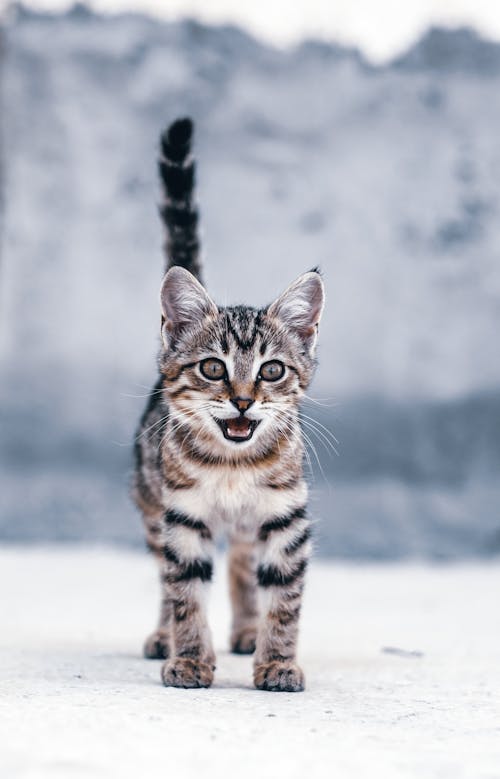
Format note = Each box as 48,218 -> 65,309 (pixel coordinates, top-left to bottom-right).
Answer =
229,542 -> 258,655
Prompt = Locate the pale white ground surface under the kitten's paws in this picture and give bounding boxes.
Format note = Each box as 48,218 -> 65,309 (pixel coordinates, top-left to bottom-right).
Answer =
0,547 -> 500,779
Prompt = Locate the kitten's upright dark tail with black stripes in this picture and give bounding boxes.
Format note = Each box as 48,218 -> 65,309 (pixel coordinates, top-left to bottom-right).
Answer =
158,118 -> 201,281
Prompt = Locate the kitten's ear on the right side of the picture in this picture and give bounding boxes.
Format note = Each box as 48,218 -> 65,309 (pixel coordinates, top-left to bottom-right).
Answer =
267,271 -> 325,352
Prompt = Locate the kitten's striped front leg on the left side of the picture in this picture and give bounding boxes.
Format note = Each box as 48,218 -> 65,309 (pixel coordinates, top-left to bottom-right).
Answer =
161,510 -> 215,687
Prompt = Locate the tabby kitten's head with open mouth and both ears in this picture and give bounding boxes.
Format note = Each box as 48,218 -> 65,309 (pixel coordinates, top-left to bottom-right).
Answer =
160,267 -> 324,459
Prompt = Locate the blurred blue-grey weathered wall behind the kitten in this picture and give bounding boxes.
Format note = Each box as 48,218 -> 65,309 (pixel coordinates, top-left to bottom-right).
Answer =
0,5 -> 500,559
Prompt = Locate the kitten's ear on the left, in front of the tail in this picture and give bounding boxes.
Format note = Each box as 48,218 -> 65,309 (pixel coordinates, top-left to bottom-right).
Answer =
160,266 -> 217,346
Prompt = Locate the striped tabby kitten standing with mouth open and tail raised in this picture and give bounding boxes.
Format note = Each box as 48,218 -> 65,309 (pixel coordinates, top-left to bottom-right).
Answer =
134,119 -> 324,692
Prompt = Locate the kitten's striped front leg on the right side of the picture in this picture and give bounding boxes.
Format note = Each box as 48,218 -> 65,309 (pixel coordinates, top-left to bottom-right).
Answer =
254,507 -> 311,692
